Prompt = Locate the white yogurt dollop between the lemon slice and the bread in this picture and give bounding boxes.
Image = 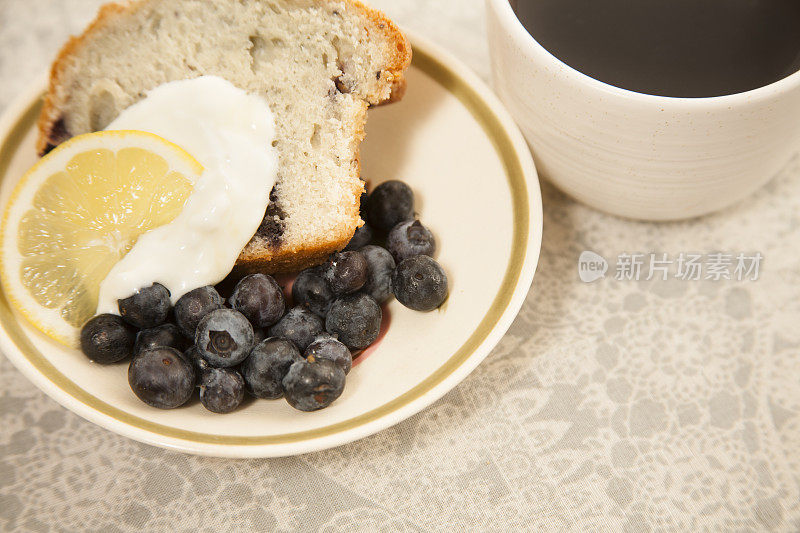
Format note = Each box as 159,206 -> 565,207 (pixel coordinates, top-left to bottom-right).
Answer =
97,76 -> 278,313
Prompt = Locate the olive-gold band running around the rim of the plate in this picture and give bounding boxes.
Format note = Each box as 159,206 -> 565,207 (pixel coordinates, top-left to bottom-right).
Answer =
0,44 -> 530,446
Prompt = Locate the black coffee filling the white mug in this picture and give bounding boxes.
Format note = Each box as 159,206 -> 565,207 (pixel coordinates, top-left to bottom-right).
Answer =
510,0 -> 800,97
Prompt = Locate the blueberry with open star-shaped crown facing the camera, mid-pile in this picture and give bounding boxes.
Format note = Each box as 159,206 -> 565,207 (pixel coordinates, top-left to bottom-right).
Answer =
194,309 -> 255,367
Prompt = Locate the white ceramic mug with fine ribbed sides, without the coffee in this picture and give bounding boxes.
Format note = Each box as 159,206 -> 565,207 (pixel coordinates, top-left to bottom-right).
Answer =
486,0 -> 800,220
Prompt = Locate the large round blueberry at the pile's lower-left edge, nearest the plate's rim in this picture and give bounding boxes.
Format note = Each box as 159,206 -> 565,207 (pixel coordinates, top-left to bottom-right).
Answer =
128,348 -> 195,409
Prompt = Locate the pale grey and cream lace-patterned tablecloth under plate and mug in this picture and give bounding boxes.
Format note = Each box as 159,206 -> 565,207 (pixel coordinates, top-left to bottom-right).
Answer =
0,0 -> 800,532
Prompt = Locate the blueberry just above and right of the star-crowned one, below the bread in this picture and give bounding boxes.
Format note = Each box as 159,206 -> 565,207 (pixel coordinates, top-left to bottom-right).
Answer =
228,274 -> 286,328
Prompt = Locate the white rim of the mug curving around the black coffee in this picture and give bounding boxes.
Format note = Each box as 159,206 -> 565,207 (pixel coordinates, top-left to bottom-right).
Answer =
487,0 -> 800,109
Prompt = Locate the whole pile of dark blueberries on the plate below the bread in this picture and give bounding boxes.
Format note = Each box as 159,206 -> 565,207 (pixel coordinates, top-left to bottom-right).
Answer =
80,181 -> 448,413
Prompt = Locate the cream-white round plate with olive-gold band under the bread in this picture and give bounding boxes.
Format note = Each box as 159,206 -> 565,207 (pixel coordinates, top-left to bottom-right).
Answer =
0,34 -> 542,457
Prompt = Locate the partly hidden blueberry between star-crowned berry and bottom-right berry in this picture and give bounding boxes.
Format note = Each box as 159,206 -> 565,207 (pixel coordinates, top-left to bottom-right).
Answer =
242,337 -> 303,400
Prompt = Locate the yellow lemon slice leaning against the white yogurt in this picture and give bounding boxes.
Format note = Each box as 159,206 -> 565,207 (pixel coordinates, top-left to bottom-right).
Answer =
0,131 -> 203,346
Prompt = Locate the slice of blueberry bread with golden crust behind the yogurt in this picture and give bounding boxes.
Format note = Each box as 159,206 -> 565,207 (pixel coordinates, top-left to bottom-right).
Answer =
38,0 -> 411,273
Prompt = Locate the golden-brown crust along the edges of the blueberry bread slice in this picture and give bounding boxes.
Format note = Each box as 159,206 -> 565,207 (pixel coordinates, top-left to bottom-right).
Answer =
36,0 -> 412,273
